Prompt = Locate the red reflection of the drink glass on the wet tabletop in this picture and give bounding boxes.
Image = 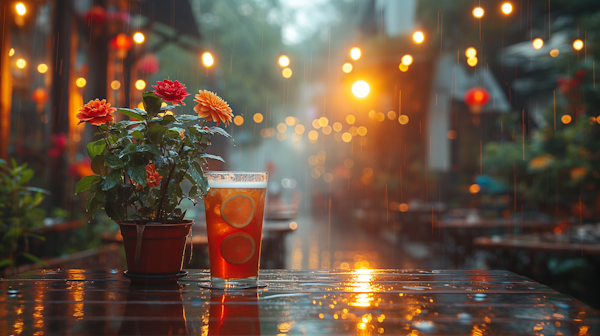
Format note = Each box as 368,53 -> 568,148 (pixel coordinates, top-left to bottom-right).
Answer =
208,289 -> 260,336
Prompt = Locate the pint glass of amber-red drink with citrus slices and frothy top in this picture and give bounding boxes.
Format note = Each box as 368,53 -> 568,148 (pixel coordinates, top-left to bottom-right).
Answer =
204,172 -> 268,288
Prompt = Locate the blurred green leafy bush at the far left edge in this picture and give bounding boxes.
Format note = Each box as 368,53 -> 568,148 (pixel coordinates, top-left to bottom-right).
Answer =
0,159 -> 48,268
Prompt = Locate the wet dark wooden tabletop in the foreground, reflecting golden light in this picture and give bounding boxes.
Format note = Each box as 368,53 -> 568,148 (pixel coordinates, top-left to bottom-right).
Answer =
0,269 -> 600,336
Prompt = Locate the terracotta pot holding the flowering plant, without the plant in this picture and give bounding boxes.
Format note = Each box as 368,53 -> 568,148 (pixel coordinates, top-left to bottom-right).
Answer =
118,220 -> 194,283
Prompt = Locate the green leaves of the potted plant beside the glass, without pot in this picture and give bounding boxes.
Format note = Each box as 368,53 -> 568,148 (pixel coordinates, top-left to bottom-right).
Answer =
76,92 -> 231,223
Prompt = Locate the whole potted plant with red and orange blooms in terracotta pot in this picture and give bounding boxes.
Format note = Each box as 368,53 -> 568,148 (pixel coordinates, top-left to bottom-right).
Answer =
76,79 -> 233,282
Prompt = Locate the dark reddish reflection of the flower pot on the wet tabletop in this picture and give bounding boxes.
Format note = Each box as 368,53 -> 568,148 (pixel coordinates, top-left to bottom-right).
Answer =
119,284 -> 188,335
